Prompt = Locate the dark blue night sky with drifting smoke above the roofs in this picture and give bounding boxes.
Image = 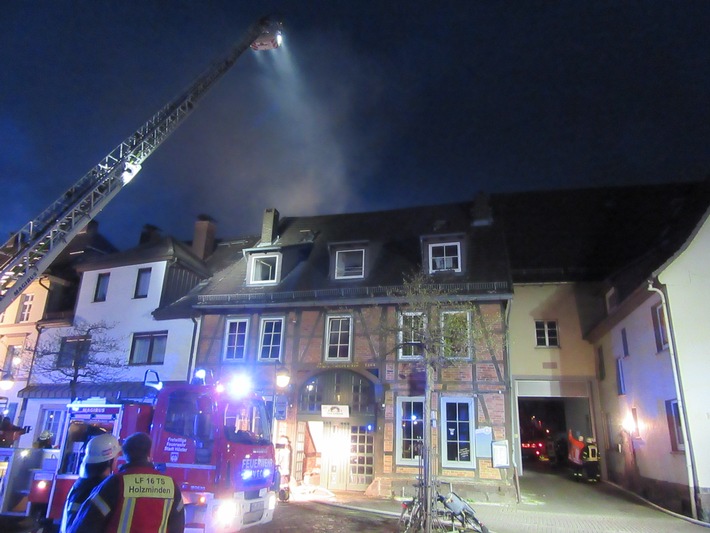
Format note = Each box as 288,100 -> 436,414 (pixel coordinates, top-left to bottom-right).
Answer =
0,0 -> 710,248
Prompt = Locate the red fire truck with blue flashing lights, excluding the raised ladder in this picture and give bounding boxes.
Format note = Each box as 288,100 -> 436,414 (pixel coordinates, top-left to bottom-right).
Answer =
4,371 -> 276,533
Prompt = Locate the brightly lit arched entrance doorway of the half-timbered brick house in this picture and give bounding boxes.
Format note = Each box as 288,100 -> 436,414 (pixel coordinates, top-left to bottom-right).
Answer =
295,370 -> 376,490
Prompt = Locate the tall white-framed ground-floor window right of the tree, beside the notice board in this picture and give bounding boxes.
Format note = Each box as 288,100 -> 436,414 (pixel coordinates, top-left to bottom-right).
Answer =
441,398 -> 476,468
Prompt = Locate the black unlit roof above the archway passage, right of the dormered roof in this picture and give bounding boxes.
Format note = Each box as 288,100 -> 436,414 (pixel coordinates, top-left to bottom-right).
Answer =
491,182 -> 710,282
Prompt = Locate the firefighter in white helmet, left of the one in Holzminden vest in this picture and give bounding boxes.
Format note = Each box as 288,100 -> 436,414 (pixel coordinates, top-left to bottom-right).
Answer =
59,433 -> 121,533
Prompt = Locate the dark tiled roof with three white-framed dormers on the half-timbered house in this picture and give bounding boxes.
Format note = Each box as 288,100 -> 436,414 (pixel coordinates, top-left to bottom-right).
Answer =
200,203 -> 510,305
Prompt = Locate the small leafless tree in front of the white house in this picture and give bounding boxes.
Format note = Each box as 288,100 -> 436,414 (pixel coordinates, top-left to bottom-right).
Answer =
32,321 -> 126,401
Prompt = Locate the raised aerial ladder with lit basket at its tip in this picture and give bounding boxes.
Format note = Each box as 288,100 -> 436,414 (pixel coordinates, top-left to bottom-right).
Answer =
0,17 -> 282,313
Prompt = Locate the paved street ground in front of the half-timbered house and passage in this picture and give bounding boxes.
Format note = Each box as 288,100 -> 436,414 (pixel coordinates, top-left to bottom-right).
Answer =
0,465 -> 710,533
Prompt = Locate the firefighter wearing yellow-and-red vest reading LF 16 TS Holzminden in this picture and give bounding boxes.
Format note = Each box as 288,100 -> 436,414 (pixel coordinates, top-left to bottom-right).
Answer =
67,433 -> 185,533
